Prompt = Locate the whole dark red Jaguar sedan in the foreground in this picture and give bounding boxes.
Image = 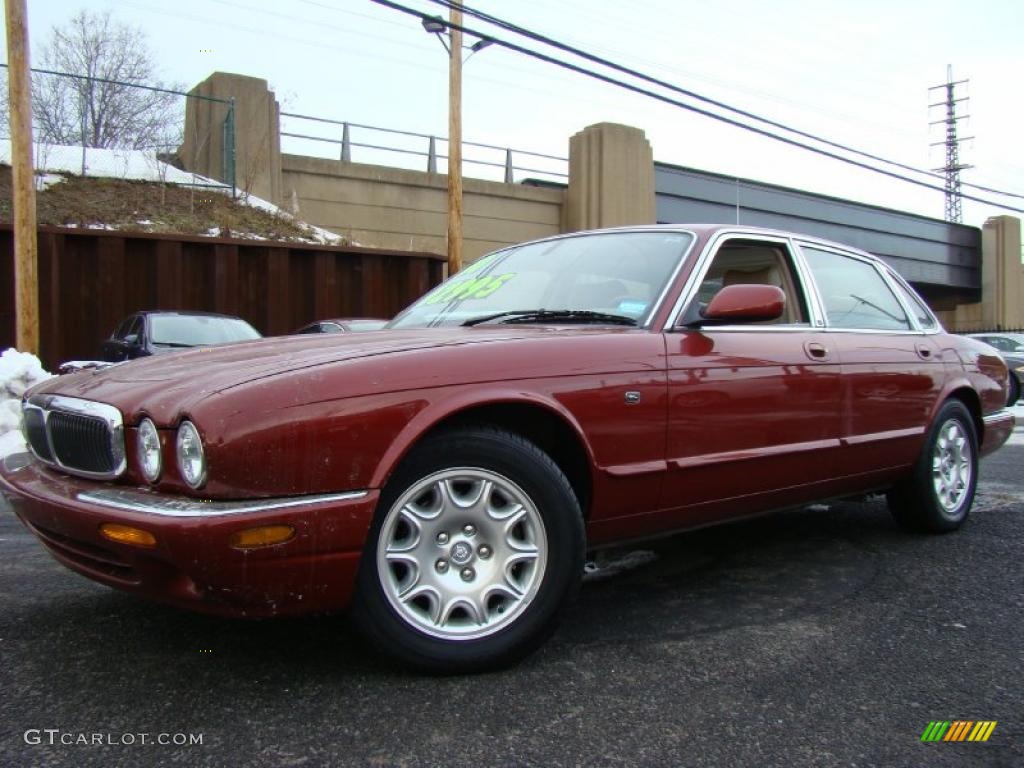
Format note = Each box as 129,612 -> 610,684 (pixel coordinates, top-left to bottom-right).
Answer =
0,225 -> 1014,671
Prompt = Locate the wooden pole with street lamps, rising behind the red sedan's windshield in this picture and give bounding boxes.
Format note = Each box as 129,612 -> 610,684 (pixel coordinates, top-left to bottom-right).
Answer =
422,7 -> 494,278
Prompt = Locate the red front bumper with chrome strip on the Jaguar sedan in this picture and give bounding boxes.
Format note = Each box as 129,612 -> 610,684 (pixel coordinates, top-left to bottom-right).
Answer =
0,454 -> 379,616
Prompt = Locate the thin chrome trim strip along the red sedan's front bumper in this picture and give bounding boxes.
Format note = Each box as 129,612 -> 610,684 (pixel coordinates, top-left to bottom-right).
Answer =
76,488 -> 370,517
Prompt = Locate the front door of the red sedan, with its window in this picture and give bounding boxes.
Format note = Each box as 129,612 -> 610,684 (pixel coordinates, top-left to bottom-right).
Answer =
663,233 -> 840,525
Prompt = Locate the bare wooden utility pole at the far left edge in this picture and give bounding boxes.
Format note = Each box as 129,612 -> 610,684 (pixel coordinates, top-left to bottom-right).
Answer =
6,0 -> 39,354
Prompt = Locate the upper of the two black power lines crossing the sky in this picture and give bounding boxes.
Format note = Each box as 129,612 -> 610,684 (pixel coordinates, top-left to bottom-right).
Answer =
429,0 -> 1024,200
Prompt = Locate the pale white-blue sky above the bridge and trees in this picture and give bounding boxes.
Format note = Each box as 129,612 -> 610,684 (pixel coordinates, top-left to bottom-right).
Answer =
3,0 -> 1024,226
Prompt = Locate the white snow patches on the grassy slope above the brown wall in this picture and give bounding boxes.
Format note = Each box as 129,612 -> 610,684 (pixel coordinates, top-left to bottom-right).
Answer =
0,139 -> 346,245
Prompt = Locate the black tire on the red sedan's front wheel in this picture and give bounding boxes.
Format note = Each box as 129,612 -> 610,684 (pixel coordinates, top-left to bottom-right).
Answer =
352,426 -> 585,674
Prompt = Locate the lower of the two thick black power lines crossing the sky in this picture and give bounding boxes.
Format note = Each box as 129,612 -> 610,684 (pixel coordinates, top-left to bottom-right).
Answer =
370,0 -> 1024,213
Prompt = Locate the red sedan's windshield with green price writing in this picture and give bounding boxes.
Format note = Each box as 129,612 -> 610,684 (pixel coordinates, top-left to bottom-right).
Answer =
388,231 -> 693,328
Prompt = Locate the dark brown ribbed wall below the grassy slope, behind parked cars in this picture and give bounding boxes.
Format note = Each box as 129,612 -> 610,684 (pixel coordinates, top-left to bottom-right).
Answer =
0,224 -> 444,371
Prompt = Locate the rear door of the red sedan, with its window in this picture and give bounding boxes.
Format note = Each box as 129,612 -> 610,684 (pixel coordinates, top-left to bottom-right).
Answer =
800,243 -> 945,475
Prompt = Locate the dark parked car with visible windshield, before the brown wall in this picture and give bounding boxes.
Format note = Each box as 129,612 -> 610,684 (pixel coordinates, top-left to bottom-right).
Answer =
99,311 -> 260,362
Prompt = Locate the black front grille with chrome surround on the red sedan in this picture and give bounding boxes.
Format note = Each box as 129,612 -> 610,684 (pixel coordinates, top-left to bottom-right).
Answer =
22,394 -> 127,480
